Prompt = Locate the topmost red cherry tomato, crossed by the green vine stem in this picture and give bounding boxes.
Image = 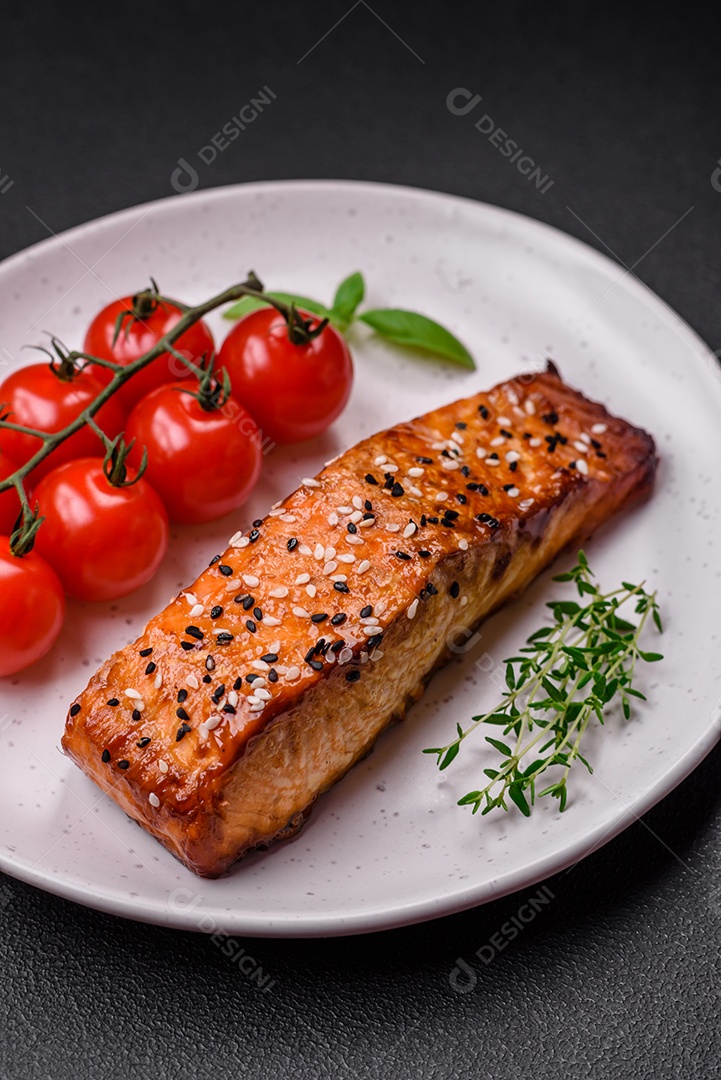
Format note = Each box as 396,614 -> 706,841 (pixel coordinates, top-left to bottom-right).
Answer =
83,296 -> 215,413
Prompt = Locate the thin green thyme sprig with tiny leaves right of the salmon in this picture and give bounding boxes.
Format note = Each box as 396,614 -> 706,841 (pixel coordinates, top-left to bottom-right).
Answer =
423,551 -> 663,818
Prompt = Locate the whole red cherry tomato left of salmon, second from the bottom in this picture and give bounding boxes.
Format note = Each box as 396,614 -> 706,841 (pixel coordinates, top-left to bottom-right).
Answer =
33,458 -> 168,600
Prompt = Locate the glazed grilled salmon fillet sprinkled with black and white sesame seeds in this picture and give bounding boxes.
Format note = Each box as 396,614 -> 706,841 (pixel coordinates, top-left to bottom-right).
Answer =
63,363 -> 656,877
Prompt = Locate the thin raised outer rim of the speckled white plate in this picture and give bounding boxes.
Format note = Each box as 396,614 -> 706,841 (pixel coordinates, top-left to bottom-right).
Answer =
0,179 -> 721,937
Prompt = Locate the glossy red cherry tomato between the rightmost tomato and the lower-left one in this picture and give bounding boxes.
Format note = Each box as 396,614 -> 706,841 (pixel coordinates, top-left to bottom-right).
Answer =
125,382 -> 262,523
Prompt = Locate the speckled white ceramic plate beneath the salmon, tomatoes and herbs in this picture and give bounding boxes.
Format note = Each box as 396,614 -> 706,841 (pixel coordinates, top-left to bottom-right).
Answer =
0,181 -> 721,936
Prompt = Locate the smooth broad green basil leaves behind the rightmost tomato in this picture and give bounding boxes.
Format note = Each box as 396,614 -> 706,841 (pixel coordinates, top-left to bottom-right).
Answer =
223,271 -> 476,370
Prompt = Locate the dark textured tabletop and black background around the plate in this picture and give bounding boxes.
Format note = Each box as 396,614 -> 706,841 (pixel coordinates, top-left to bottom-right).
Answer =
0,0 -> 721,1080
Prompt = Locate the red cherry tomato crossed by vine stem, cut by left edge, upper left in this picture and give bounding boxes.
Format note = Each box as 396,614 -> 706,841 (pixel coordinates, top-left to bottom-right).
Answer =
0,364 -> 125,482
